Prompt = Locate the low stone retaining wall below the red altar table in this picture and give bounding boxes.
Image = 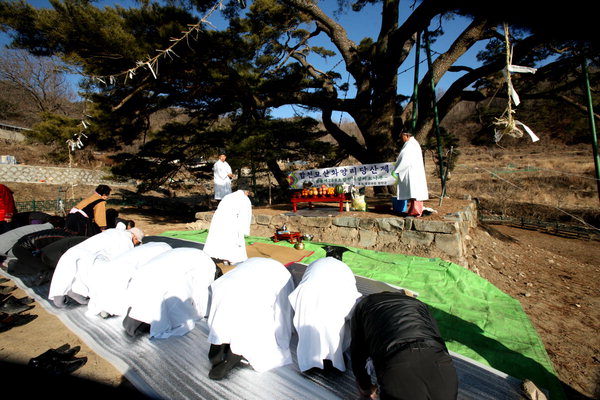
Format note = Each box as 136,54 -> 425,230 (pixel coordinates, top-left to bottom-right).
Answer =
192,202 -> 477,267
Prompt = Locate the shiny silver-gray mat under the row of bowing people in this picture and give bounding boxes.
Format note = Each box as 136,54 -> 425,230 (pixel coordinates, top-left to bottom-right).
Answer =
0,237 -> 522,400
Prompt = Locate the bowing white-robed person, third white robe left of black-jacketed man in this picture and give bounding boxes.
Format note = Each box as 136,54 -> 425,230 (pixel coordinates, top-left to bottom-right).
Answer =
127,247 -> 217,339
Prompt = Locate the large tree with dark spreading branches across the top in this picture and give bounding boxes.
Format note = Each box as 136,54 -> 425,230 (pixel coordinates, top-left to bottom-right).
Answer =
0,0 -> 596,189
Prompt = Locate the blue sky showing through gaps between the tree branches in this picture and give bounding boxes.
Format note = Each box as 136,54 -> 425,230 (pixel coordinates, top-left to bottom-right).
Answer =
0,0 -> 483,121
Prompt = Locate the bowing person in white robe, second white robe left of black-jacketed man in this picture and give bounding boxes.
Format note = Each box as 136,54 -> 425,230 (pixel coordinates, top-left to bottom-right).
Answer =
208,257 -> 294,379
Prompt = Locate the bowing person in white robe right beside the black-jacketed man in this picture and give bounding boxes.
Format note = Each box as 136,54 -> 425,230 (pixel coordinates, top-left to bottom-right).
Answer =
289,257 -> 361,372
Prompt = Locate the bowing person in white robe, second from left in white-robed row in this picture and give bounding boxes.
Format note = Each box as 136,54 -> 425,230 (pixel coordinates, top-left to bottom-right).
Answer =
88,242 -> 172,315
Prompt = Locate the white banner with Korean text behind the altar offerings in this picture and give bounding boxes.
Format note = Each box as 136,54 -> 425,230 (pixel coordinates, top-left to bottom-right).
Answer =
288,162 -> 397,189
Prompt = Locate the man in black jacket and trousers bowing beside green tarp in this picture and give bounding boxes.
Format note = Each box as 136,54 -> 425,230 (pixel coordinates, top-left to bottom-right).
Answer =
350,292 -> 458,400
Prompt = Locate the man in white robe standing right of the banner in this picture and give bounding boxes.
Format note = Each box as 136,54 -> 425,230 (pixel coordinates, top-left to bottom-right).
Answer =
394,132 -> 429,217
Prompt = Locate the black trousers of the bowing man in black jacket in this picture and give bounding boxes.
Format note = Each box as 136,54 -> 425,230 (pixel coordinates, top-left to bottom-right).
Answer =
375,343 -> 458,400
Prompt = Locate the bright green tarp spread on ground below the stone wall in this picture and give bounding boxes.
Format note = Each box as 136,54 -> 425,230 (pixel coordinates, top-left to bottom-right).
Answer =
162,230 -> 565,399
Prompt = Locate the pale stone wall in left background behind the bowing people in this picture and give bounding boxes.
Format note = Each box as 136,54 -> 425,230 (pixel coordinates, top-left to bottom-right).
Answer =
0,164 -> 125,186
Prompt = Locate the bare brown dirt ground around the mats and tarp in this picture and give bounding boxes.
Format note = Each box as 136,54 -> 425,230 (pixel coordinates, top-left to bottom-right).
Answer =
0,186 -> 600,399
